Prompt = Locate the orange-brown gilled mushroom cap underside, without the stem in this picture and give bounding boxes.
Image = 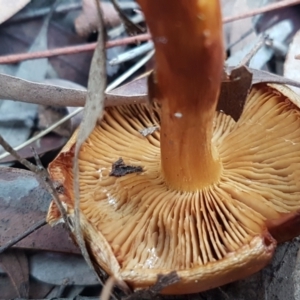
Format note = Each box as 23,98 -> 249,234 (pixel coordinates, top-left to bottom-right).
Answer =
47,84 -> 300,294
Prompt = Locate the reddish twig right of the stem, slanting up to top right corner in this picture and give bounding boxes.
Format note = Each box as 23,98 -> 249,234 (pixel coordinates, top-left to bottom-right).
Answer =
223,0 -> 300,23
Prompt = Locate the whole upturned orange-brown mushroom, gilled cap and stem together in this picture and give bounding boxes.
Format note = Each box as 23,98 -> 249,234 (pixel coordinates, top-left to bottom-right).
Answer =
47,0 -> 300,294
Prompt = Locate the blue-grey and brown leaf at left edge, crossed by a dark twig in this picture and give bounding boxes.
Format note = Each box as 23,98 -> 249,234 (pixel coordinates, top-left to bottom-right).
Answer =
0,167 -> 79,253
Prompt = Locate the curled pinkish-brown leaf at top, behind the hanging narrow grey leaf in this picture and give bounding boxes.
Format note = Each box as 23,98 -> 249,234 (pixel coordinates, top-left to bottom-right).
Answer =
75,0 -> 121,37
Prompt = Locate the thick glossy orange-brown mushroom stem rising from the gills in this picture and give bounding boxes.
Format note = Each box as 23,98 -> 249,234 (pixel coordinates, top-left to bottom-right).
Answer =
139,0 -> 224,191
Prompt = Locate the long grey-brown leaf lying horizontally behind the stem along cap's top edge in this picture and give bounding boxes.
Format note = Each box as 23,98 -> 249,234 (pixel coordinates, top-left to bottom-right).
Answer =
0,68 -> 300,122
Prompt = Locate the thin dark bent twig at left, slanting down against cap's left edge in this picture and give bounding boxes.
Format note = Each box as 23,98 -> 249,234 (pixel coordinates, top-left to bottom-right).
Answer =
0,135 -> 70,230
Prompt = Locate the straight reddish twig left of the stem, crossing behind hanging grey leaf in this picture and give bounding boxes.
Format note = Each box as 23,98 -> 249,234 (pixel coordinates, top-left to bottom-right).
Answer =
0,33 -> 151,64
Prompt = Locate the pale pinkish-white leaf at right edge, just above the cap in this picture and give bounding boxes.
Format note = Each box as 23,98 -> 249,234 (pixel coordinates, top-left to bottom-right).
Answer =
283,30 -> 300,95
